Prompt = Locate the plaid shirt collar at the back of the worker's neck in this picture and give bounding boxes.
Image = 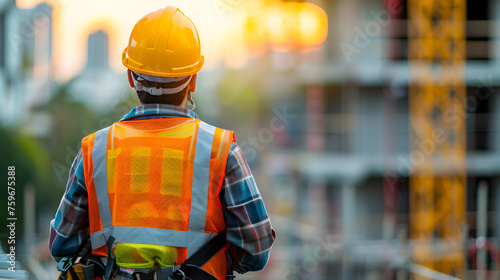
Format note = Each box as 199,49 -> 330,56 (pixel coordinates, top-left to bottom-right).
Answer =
120,104 -> 199,121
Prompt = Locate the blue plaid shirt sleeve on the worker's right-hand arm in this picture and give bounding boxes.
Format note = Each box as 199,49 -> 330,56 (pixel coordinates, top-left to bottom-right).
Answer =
220,142 -> 276,273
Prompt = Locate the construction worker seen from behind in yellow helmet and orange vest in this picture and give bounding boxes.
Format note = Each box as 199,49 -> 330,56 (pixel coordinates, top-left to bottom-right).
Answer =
49,6 -> 275,280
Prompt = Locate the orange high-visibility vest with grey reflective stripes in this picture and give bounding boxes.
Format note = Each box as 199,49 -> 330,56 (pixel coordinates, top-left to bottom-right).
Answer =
82,118 -> 234,279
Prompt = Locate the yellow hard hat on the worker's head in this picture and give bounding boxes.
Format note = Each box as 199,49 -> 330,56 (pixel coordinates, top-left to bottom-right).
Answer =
122,6 -> 204,77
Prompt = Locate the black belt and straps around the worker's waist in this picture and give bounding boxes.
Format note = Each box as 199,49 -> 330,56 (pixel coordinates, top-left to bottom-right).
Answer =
104,230 -> 236,280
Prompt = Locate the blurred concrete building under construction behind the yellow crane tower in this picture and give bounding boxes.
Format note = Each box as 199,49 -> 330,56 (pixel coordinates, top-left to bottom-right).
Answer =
230,0 -> 500,279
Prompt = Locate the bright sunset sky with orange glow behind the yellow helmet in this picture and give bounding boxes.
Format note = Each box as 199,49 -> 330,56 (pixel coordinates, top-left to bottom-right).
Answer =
17,0 -> 328,82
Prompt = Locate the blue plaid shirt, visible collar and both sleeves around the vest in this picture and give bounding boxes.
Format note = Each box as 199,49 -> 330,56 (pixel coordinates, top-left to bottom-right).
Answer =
49,104 -> 276,273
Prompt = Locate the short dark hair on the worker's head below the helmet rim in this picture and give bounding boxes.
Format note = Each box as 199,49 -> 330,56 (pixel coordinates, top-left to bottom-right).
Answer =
132,72 -> 187,106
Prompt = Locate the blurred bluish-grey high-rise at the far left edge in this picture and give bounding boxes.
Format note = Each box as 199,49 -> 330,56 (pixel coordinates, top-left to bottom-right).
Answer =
0,1 -> 53,135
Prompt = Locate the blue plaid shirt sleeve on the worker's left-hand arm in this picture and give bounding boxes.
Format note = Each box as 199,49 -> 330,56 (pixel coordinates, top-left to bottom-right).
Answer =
49,149 -> 90,261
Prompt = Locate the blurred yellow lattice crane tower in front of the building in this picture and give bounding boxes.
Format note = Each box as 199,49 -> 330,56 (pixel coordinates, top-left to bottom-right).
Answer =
408,0 -> 466,279
